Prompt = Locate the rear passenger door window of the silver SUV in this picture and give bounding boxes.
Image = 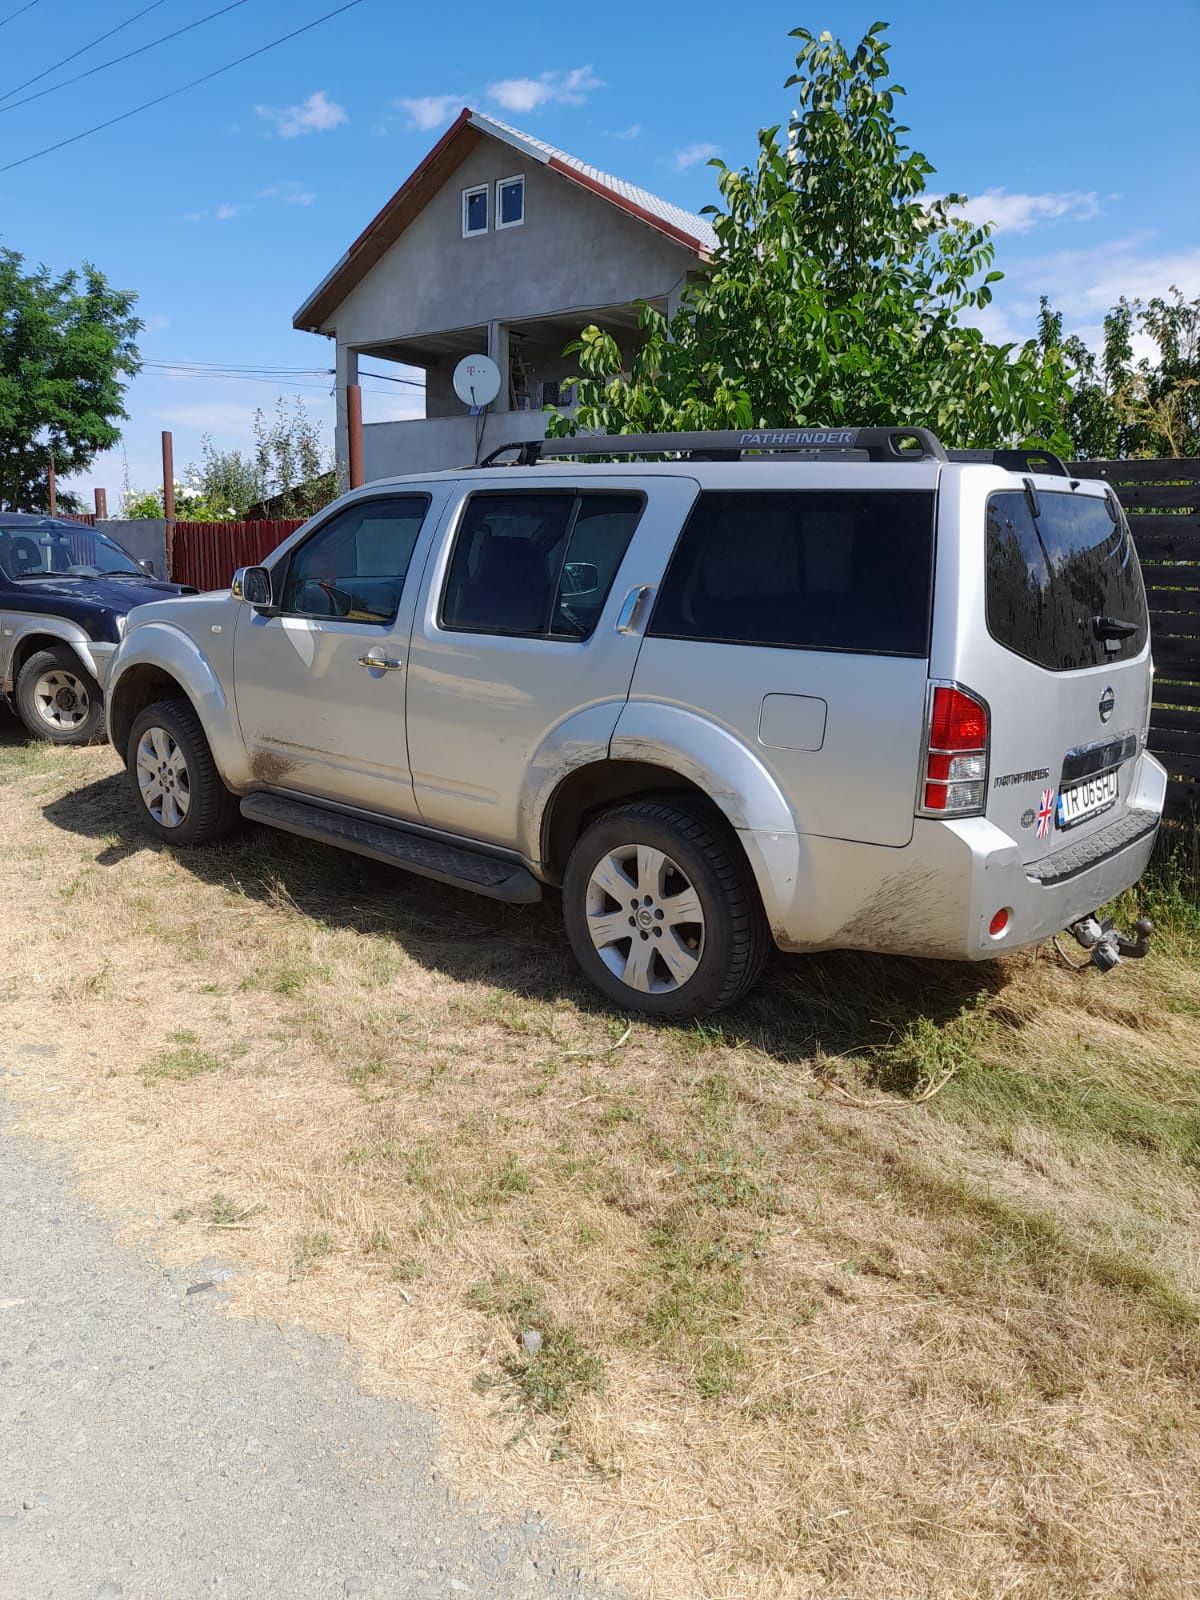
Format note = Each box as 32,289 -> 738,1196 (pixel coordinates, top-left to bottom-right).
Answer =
442,490 -> 645,638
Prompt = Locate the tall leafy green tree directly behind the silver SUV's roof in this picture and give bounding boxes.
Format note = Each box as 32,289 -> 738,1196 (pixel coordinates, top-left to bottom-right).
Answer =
550,22 -> 1066,448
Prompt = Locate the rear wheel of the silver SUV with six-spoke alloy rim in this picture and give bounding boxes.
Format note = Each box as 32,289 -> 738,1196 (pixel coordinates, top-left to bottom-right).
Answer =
563,798 -> 770,1021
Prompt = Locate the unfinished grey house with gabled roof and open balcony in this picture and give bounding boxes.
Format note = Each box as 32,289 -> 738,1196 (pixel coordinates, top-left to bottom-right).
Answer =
293,107 -> 715,478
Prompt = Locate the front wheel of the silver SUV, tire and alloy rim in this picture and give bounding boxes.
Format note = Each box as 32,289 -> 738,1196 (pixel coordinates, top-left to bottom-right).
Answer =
125,699 -> 240,845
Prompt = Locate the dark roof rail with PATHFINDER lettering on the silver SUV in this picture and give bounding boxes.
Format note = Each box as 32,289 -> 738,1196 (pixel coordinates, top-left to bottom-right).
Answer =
480,427 -> 949,467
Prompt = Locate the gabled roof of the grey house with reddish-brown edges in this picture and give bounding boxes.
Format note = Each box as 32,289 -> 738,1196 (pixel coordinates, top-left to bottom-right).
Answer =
291,106 -> 717,333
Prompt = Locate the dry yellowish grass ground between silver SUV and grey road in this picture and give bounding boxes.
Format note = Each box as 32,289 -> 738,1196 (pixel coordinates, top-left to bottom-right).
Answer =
0,741 -> 1200,1600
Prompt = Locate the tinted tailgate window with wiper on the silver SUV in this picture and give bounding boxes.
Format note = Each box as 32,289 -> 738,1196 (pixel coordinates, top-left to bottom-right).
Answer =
987,490 -> 1147,672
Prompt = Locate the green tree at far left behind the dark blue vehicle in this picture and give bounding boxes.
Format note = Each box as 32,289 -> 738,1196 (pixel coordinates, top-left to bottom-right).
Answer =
0,246 -> 142,510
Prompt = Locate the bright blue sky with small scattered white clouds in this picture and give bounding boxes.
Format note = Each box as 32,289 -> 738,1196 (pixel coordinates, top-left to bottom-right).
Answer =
0,0 -> 1200,504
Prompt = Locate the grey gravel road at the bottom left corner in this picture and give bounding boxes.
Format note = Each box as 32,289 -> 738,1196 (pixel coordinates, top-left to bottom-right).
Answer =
0,1109 -> 614,1600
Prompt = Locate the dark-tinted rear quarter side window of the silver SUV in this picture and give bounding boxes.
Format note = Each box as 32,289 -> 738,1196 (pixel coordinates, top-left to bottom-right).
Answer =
648,490 -> 933,656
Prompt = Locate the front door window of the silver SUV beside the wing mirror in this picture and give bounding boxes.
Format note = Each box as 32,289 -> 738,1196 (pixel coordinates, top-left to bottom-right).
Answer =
280,494 -> 429,622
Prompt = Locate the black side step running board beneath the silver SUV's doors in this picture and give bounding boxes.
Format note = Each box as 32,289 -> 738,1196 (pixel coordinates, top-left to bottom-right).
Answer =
242,794 -> 542,906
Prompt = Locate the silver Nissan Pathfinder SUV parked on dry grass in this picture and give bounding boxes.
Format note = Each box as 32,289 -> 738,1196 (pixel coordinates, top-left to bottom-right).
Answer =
107,429 -> 1166,1018
